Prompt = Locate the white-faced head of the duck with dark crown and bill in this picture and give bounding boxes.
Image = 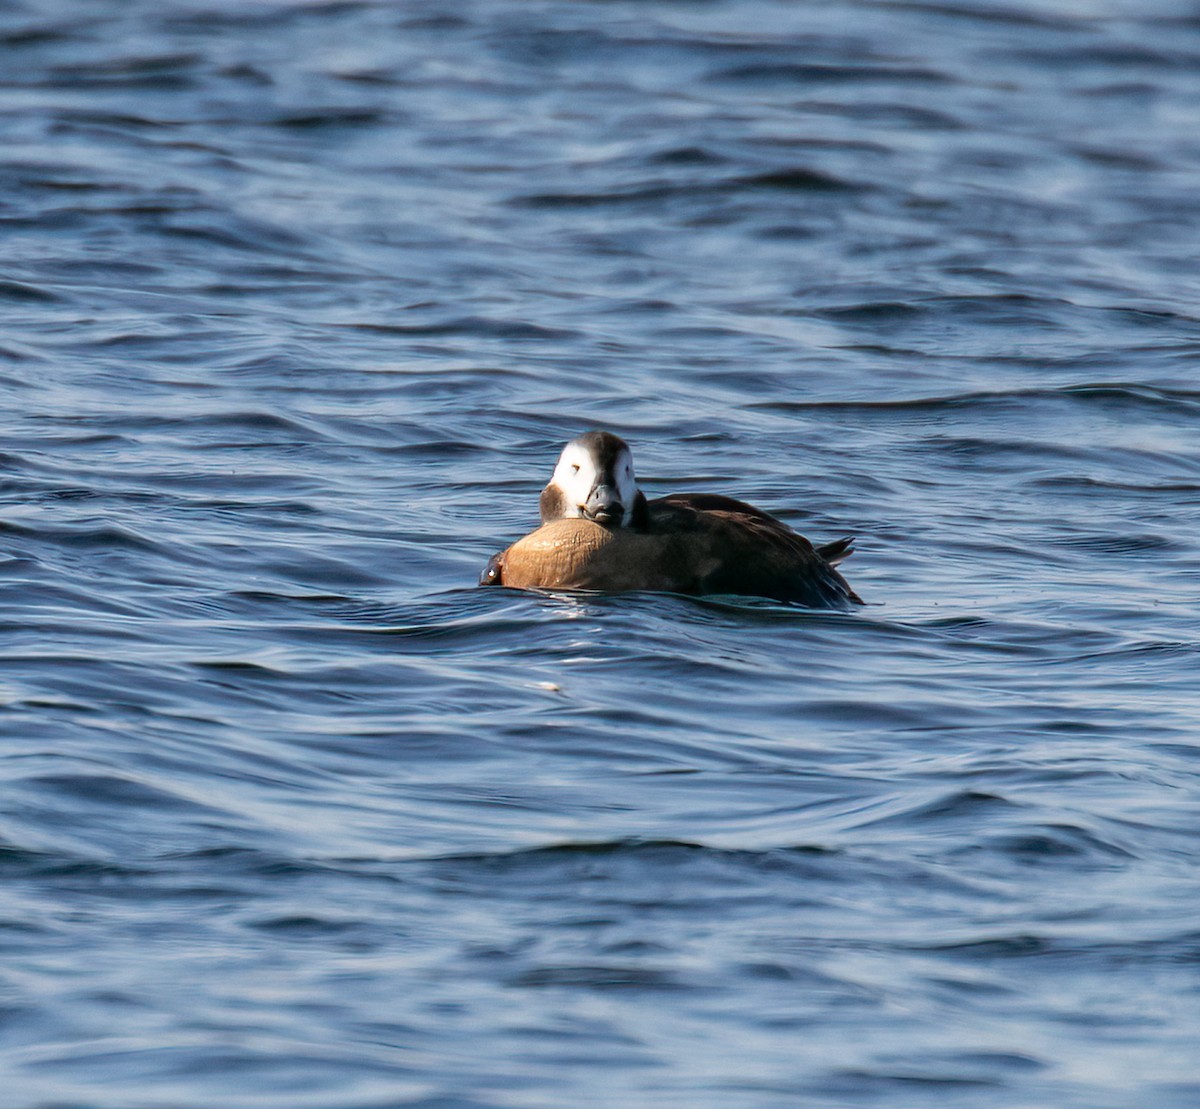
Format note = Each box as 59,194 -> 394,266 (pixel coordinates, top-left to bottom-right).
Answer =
540,431 -> 647,528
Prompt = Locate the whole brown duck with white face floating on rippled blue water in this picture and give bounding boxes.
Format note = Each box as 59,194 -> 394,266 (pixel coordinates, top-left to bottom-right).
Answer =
479,431 -> 864,609
